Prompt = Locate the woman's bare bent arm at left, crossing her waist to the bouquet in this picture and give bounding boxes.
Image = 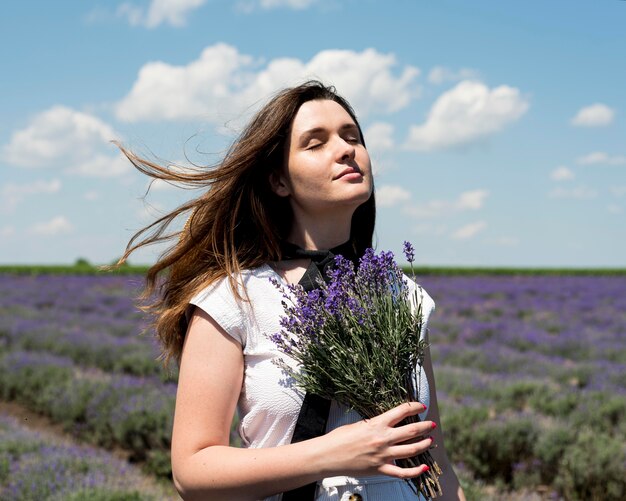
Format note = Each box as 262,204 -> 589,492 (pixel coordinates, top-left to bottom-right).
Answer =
172,308 -> 432,501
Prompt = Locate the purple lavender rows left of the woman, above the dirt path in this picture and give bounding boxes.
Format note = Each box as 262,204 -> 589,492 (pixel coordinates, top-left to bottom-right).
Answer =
0,275 -> 176,484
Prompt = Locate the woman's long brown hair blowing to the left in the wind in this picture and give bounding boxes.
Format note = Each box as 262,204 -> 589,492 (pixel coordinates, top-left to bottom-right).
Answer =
117,80 -> 376,365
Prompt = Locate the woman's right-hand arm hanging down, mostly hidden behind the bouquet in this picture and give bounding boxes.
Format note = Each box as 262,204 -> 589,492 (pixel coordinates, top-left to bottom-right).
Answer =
424,348 -> 465,501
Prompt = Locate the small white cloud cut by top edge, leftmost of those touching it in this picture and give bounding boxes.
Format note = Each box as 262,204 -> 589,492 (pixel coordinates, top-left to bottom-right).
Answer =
117,0 -> 206,28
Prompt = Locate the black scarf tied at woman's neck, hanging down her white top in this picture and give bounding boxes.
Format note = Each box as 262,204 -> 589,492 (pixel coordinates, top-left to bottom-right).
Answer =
281,242 -> 358,501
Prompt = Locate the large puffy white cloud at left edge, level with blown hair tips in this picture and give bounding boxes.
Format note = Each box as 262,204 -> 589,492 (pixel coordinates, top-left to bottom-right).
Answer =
2,106 -> 130,177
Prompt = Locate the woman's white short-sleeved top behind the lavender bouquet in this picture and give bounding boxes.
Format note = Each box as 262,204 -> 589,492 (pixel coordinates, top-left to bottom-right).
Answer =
190,265 -> 435,501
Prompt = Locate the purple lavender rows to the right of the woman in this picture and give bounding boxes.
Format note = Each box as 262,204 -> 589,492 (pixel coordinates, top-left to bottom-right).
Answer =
420,275 -> 626,500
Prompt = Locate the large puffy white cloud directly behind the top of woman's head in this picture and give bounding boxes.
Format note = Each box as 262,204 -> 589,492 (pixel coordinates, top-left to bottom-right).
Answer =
116,43 -> 419,124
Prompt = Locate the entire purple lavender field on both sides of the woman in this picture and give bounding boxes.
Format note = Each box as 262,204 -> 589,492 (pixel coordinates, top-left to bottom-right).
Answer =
0,274 -> 626,501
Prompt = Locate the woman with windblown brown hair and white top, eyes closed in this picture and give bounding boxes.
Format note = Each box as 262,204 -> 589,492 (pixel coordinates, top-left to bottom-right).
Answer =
118,81 -> 464,500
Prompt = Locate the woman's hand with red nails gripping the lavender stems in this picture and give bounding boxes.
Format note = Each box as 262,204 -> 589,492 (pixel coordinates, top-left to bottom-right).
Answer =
320,402 -> 436,479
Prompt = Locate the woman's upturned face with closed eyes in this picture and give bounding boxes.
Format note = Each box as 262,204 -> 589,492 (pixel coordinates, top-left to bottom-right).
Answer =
272,100 -> 373,216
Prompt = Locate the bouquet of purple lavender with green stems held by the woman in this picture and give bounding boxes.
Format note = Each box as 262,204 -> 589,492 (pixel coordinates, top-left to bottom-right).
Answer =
272,242 -> 442,498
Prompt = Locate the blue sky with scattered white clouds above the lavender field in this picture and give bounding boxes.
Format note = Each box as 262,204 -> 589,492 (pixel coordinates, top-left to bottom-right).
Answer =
0,0 -> 626,267
